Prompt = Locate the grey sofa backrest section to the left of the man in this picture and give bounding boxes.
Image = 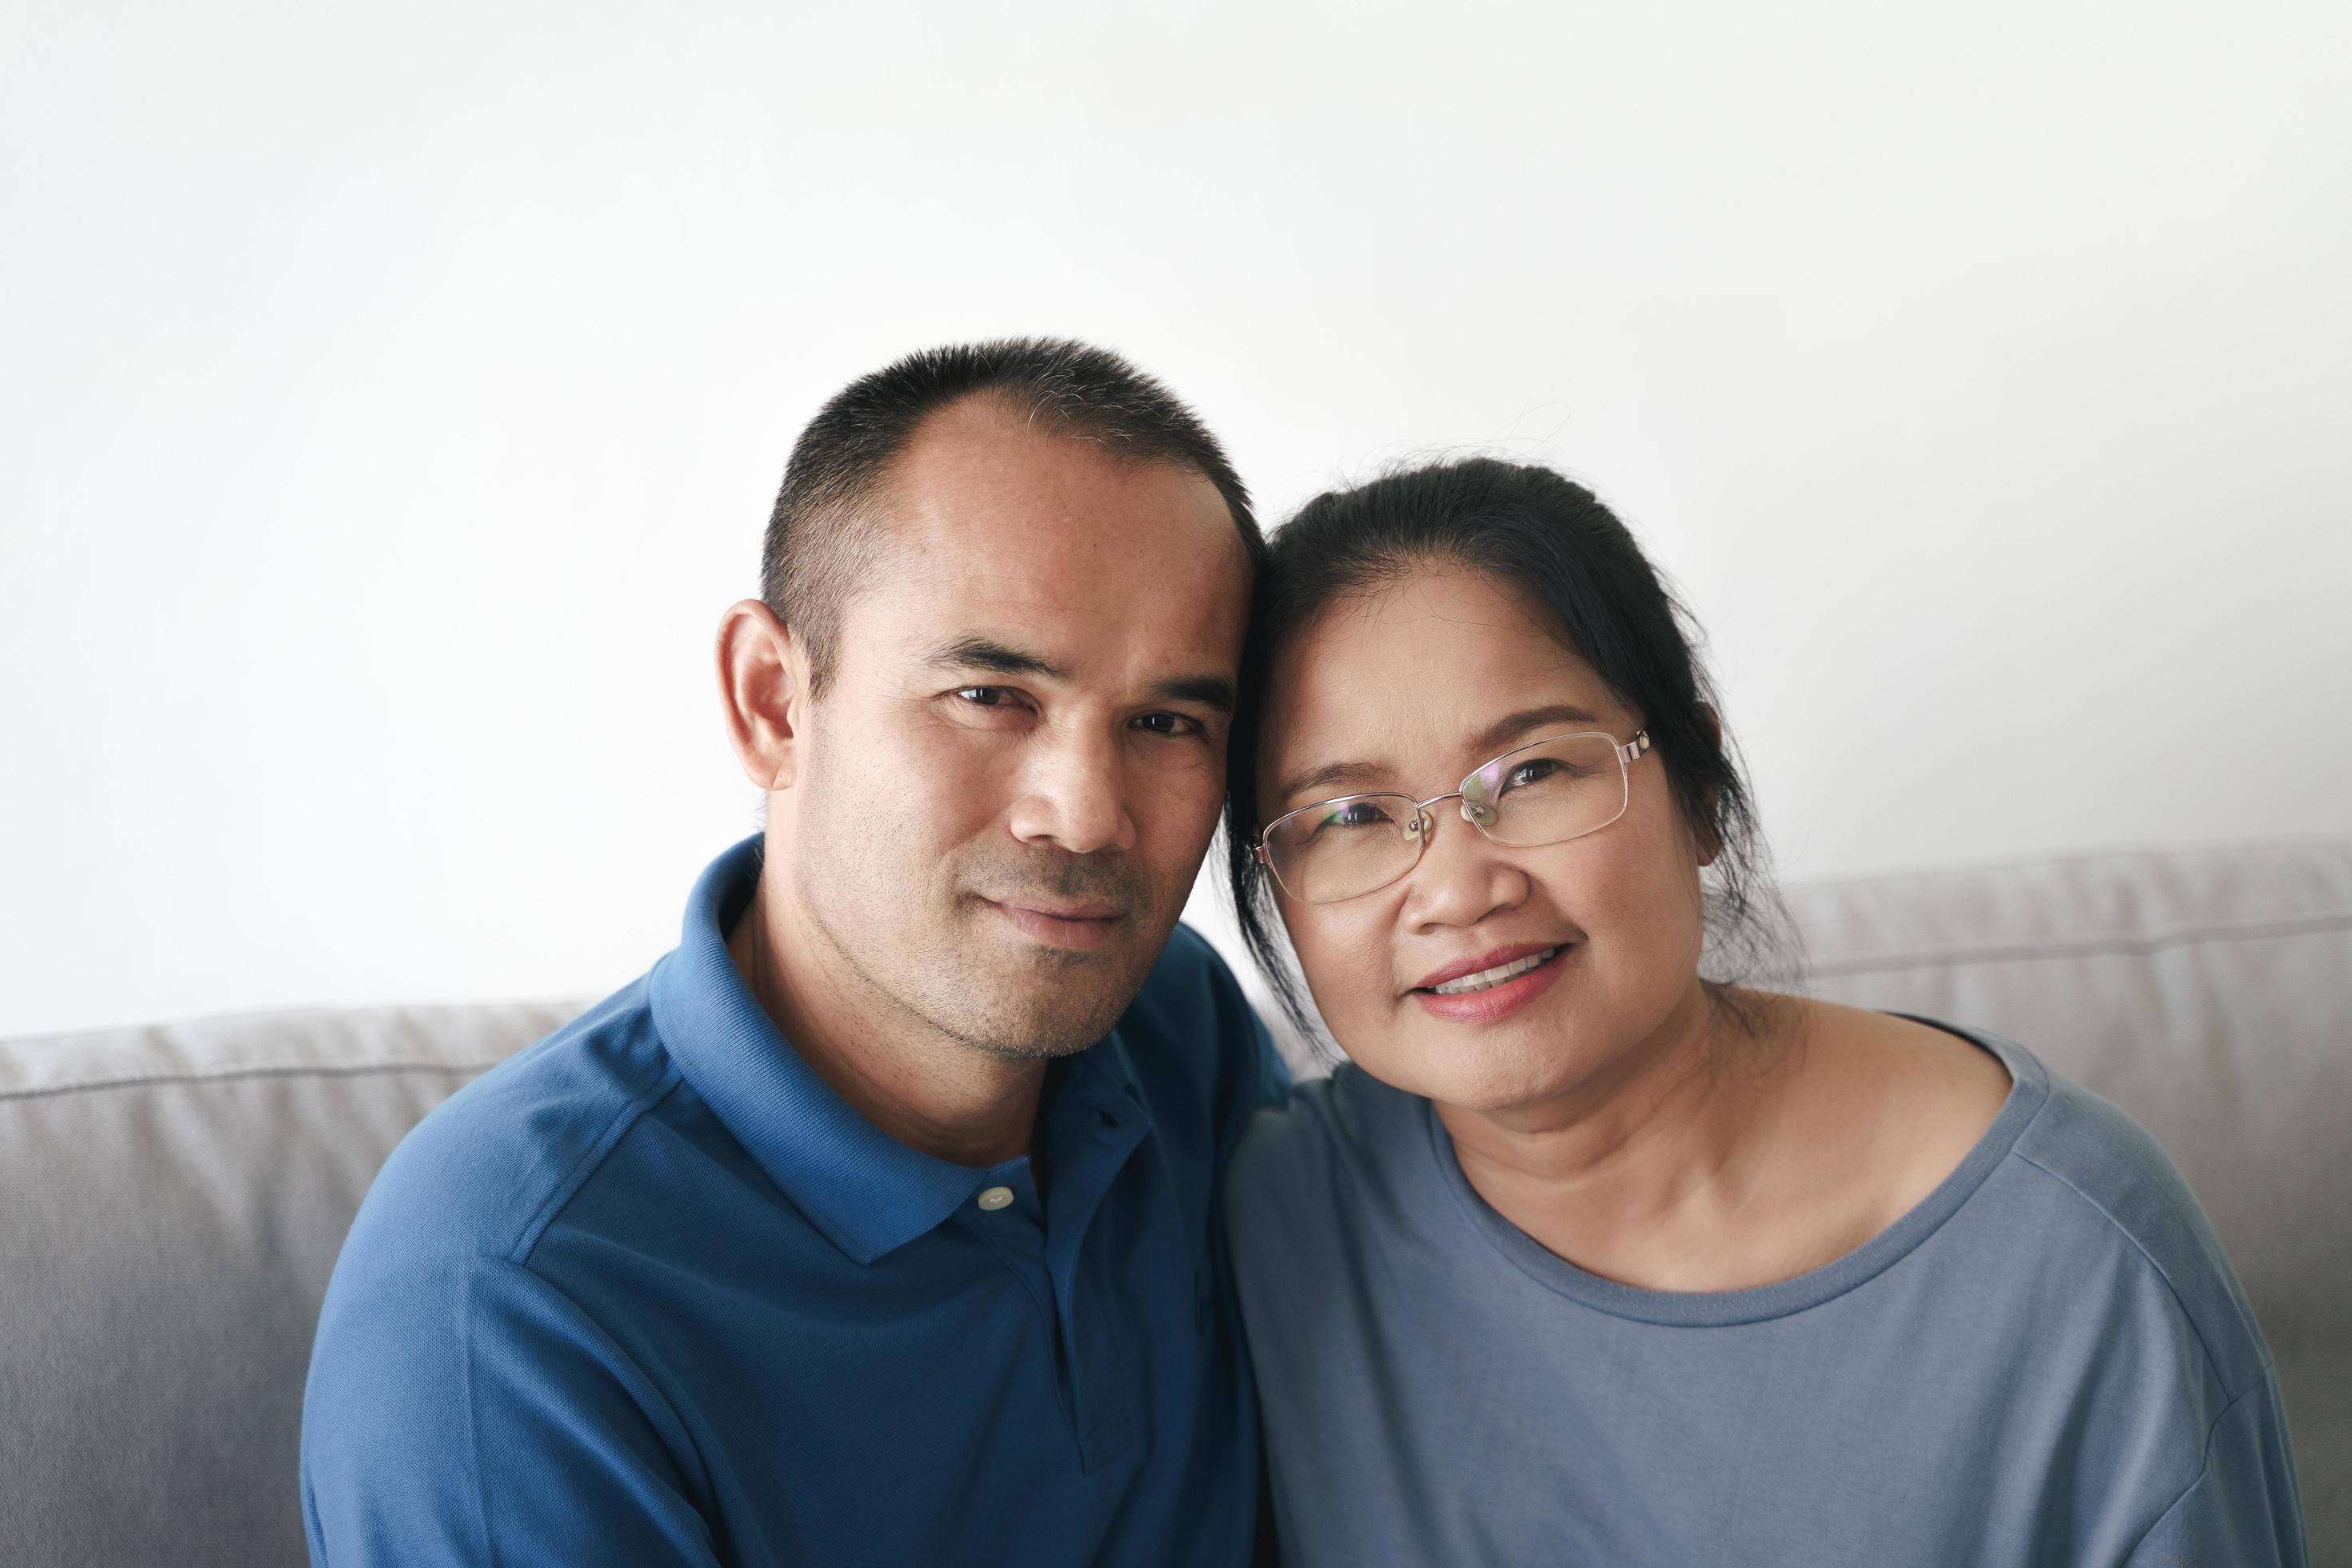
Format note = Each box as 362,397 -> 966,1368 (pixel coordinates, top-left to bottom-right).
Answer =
0,1006 -> 576,1568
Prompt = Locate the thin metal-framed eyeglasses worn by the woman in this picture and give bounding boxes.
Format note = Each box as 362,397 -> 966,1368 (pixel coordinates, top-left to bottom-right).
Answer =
1256,729 -> 1649,902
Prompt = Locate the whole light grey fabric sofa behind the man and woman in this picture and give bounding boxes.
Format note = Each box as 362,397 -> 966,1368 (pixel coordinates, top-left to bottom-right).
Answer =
0,842 -> 2352,1568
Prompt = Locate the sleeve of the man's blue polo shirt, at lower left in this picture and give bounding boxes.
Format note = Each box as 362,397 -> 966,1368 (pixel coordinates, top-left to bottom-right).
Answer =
301,1258 -> 718,1568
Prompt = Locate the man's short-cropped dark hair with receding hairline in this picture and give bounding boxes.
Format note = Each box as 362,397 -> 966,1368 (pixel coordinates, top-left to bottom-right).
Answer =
760,338 -> 1266,691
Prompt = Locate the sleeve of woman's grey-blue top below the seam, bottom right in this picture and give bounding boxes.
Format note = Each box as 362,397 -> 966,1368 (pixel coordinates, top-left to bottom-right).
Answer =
2124,1378 -> 2307,1568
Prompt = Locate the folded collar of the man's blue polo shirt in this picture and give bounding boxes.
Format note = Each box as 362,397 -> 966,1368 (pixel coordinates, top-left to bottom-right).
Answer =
651,834 -> 1141,1265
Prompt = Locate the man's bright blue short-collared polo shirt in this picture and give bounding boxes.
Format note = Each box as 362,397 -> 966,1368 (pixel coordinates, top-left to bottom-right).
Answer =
301,839 -> 1286,1568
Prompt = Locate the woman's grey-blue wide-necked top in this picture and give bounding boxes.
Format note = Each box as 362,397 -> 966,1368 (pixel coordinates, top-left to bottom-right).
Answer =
1228,1030 -> 2305,1568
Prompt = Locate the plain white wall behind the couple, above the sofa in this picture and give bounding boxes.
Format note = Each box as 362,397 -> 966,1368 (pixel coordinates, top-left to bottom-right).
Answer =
0,0 -> 2352,1034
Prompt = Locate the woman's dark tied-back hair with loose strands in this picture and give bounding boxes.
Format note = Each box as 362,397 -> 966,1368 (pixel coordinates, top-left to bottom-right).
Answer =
1226,458 -> 1797,1039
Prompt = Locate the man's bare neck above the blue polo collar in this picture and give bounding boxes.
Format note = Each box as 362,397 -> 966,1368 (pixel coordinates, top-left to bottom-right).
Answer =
726,874 -> 1046,1166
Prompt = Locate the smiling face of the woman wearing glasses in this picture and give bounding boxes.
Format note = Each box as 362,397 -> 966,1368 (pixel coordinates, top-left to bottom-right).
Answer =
1258,564 -> 1706,1112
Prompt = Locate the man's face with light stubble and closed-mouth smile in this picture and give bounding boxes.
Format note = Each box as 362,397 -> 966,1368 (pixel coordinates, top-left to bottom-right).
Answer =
771,402 -> 1249,1055
